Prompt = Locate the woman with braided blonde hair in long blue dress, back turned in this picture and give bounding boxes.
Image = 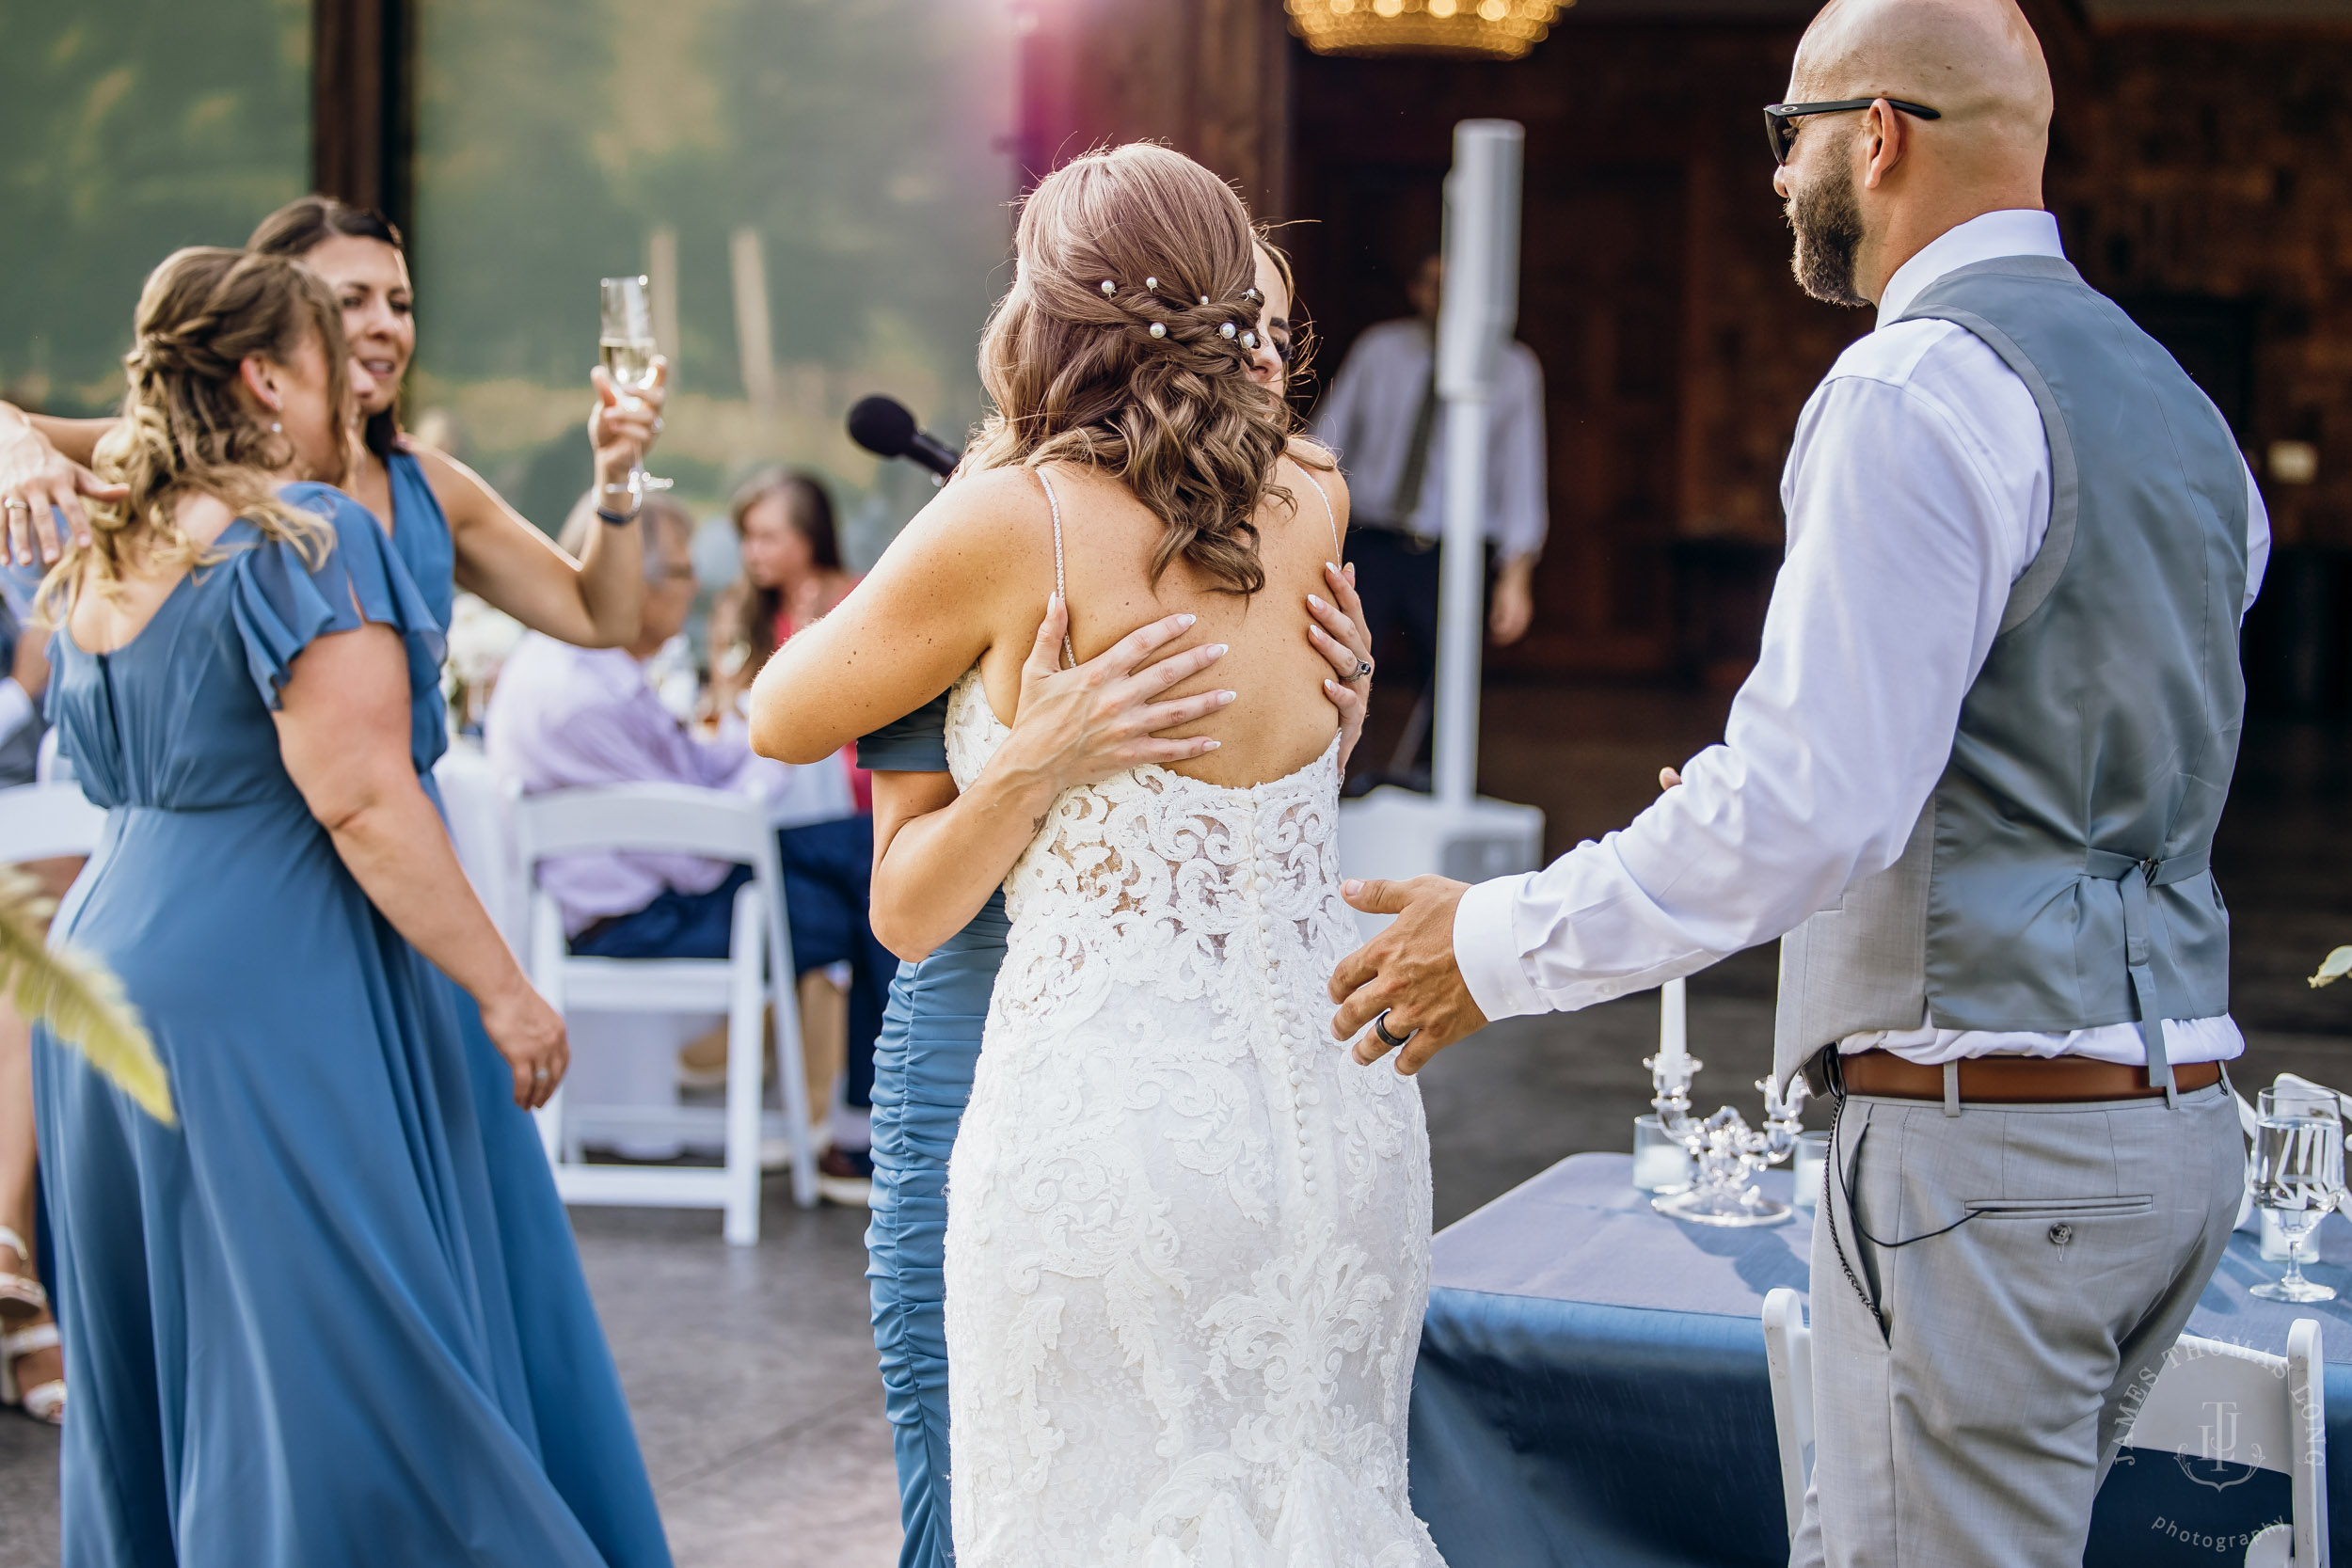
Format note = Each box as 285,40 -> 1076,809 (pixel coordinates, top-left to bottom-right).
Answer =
36,249 -> 668,1568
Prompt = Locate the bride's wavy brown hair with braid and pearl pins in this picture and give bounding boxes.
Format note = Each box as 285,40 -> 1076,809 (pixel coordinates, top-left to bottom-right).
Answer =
967,141 -> 1327,594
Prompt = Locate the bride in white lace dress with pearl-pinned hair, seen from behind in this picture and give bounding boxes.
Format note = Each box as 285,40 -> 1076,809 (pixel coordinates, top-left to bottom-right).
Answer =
753,146 -> 1442,1568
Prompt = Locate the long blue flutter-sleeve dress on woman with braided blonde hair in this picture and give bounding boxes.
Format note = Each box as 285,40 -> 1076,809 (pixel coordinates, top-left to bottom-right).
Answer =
33,484 -> 671,1568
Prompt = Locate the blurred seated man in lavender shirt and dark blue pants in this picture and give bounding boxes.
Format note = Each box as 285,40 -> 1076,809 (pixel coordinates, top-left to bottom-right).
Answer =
483,496 -> 898,1190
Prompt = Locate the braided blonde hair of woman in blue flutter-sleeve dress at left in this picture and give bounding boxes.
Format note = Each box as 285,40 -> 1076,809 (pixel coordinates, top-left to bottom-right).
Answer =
45,245 -> 351,597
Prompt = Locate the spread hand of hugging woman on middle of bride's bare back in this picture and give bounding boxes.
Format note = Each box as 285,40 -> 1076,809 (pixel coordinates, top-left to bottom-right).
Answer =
991,594 -> 1235,792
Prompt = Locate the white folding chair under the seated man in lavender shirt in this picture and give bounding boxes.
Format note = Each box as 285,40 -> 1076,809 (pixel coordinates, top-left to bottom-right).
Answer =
516,785 -> 817,1246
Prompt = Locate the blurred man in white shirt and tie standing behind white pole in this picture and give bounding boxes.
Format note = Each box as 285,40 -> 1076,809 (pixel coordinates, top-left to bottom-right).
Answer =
1315,256 -> 1550,795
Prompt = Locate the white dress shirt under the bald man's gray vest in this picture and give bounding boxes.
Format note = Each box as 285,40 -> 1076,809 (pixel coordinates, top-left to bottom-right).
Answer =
1454,212 -> 2270,1065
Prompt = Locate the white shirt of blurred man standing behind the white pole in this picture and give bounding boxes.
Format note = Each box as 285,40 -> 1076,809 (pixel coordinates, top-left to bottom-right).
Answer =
1315,317 -> 1550,562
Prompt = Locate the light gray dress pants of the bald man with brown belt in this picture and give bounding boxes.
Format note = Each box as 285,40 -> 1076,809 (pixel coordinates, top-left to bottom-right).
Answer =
1790,1082 -> 2244,1568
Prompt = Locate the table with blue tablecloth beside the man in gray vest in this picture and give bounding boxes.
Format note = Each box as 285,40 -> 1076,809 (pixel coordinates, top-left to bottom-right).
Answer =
1411,1154 -> 2352,1568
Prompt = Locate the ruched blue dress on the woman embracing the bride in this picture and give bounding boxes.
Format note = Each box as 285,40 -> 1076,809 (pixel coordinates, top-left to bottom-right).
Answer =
859,693 -> 1007,1568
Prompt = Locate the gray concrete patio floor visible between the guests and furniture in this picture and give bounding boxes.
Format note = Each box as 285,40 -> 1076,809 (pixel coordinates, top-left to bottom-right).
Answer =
0,689 -> 2352,1568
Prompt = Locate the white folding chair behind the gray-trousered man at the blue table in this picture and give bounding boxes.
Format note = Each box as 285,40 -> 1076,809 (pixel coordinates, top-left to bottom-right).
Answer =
1764,1286 -> 2328,1568
